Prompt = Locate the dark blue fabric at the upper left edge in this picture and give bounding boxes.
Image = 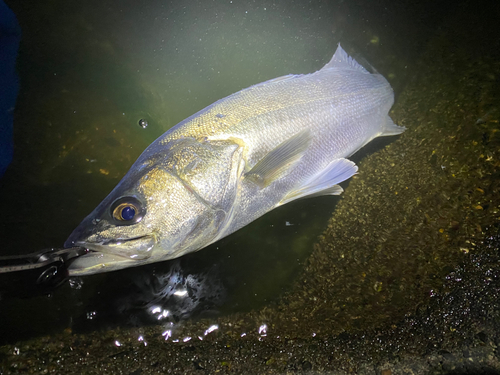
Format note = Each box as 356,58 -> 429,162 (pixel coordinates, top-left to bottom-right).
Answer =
0,0 -> 21,177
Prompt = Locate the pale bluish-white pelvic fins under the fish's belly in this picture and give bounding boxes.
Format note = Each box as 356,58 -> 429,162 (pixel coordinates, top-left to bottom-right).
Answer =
278,158 -> 358,206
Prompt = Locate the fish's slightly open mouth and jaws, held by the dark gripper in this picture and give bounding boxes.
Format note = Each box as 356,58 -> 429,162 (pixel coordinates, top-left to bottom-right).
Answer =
65,234 -> 157,276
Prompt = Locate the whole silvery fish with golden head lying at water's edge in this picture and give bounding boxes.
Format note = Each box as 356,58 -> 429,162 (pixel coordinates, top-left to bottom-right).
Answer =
65,45 -> 404,275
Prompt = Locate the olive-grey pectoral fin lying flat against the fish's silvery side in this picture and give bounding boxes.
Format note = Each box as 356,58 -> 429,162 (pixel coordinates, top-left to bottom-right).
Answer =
245,130 -> 311,188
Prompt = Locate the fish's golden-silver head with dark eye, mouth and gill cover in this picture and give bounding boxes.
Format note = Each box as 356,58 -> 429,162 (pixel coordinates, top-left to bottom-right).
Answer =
64,139 -> 245,275
